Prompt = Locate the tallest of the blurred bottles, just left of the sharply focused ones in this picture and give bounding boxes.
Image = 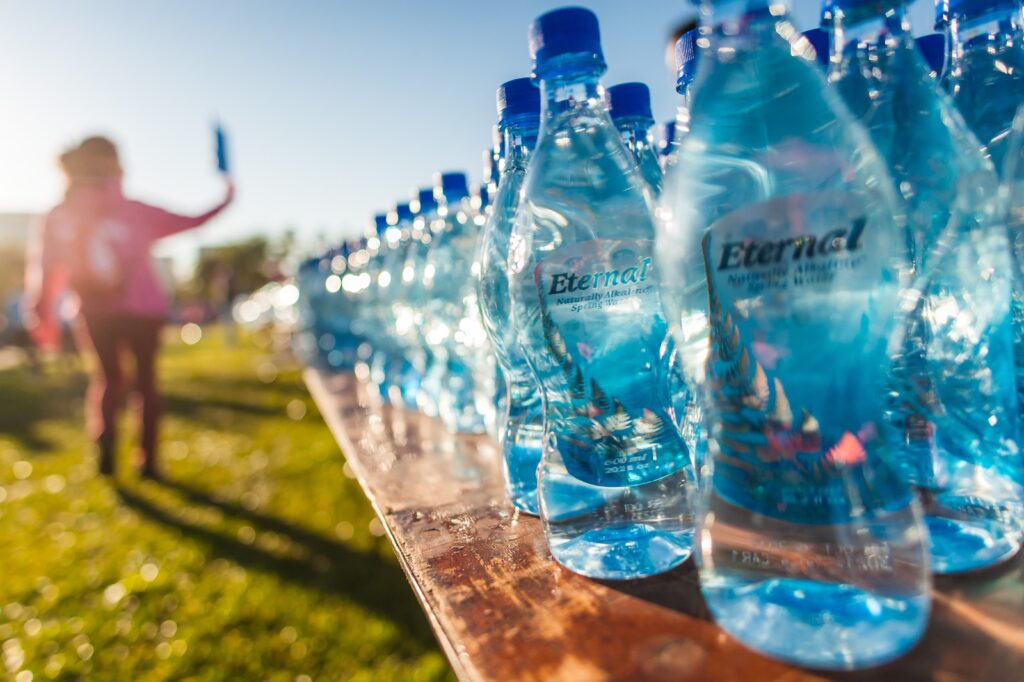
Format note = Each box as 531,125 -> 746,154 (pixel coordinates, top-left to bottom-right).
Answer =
423,173 -> 494,433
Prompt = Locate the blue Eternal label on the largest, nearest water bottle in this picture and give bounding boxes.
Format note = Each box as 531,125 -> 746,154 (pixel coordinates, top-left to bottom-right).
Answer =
701,190 -> 906,523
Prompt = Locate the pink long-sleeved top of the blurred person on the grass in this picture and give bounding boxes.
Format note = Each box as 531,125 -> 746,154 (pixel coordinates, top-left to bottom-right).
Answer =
26,183 -> 231,327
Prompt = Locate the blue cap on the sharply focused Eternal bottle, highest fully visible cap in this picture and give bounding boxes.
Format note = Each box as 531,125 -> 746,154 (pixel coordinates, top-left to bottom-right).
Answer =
529,7 -> 605,77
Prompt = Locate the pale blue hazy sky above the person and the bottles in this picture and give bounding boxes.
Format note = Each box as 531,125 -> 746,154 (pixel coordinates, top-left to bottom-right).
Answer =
0,0 -> 931,262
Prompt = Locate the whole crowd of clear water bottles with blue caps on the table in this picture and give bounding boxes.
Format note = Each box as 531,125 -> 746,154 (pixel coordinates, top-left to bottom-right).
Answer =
300,0 -> 1024,669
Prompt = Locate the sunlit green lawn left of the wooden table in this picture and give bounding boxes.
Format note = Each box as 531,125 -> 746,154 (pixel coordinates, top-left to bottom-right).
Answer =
0,330 -> 452,682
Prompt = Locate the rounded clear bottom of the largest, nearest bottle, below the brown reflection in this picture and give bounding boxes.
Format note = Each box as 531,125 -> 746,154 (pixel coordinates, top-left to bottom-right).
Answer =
700,576 -> 929,670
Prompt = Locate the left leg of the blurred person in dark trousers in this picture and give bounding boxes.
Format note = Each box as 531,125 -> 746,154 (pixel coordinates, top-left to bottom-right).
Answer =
78,317 -> 124,474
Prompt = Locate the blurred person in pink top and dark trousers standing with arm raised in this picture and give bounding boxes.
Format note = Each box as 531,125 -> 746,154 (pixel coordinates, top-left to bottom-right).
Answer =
26,137 -> 234,477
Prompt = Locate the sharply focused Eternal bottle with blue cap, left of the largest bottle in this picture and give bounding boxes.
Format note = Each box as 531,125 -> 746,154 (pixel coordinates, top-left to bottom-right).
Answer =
509,7 -> 693,579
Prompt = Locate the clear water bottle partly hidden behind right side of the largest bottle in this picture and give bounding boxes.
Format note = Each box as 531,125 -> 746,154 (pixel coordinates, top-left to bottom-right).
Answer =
830,0 -> 1024,573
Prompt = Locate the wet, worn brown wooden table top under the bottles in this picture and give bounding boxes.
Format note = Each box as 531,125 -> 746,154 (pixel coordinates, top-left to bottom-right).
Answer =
305,370 -> 1024,682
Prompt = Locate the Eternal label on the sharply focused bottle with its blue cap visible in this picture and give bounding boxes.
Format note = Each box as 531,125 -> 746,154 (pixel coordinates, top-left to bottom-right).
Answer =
535,239 -> 689,486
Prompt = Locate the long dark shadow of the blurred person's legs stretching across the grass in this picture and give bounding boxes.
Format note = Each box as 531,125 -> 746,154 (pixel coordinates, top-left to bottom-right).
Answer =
116,481 -> 437,653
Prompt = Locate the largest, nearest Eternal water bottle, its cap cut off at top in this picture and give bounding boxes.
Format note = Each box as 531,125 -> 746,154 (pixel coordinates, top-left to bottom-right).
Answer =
656,0 -> 930,669
